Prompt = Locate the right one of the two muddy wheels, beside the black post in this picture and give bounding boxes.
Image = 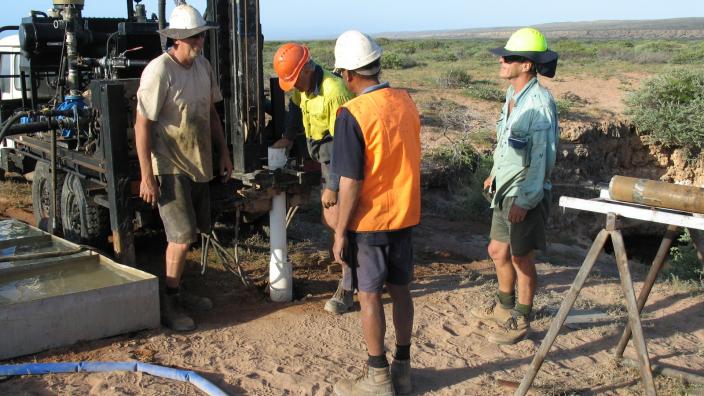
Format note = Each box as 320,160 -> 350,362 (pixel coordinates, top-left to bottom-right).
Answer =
61,174 -> 109,246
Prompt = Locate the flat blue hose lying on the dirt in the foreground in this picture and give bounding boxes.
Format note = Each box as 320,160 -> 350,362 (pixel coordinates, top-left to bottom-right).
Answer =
0,362 -> 227,396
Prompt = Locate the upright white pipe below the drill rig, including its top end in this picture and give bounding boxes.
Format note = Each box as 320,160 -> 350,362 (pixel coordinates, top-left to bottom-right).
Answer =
269,147 -> 293,302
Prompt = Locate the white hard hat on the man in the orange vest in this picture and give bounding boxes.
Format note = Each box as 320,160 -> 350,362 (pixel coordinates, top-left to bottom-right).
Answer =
335,30 -> 381,74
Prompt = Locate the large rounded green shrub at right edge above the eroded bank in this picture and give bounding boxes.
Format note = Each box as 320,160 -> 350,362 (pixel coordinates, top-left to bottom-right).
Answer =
627,69 -> 704,151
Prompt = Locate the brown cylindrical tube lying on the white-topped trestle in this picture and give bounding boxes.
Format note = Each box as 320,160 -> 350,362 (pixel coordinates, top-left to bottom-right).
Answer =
609,175 -> 704,213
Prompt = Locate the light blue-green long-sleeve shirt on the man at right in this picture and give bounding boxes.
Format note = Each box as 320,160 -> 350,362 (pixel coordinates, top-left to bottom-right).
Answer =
491,78 -> 559,209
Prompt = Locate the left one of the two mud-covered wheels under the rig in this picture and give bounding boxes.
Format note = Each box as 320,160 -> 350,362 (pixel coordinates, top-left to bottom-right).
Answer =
32,162 -> 66,231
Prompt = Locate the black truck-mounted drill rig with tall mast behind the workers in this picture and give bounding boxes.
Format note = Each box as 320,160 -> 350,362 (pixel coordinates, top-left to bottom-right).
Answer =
0,0 -> 320,265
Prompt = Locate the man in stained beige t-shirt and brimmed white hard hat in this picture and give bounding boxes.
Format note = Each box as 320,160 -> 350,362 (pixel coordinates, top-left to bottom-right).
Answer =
135,4 -> 232,331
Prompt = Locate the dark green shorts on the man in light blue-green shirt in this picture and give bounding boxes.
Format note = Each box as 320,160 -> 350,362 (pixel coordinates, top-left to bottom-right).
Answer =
489,190 -> 551,256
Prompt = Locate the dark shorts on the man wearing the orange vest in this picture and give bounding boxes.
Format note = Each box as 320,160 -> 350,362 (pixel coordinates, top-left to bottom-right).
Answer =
345,228 -> 413,293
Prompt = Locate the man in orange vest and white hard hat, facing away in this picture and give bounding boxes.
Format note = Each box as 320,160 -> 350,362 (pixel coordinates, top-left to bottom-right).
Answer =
332,30 -> 420,396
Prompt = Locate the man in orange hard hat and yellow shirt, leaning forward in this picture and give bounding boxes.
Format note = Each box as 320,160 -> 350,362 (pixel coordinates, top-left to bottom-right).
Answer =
273,43 -> 354,315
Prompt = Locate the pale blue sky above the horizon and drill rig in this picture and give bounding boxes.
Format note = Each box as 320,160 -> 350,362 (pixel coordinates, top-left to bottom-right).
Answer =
0,0 -> 704,40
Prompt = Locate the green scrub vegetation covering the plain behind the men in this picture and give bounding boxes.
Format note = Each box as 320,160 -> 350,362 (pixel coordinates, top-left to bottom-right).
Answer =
264,37 -> 704,217
